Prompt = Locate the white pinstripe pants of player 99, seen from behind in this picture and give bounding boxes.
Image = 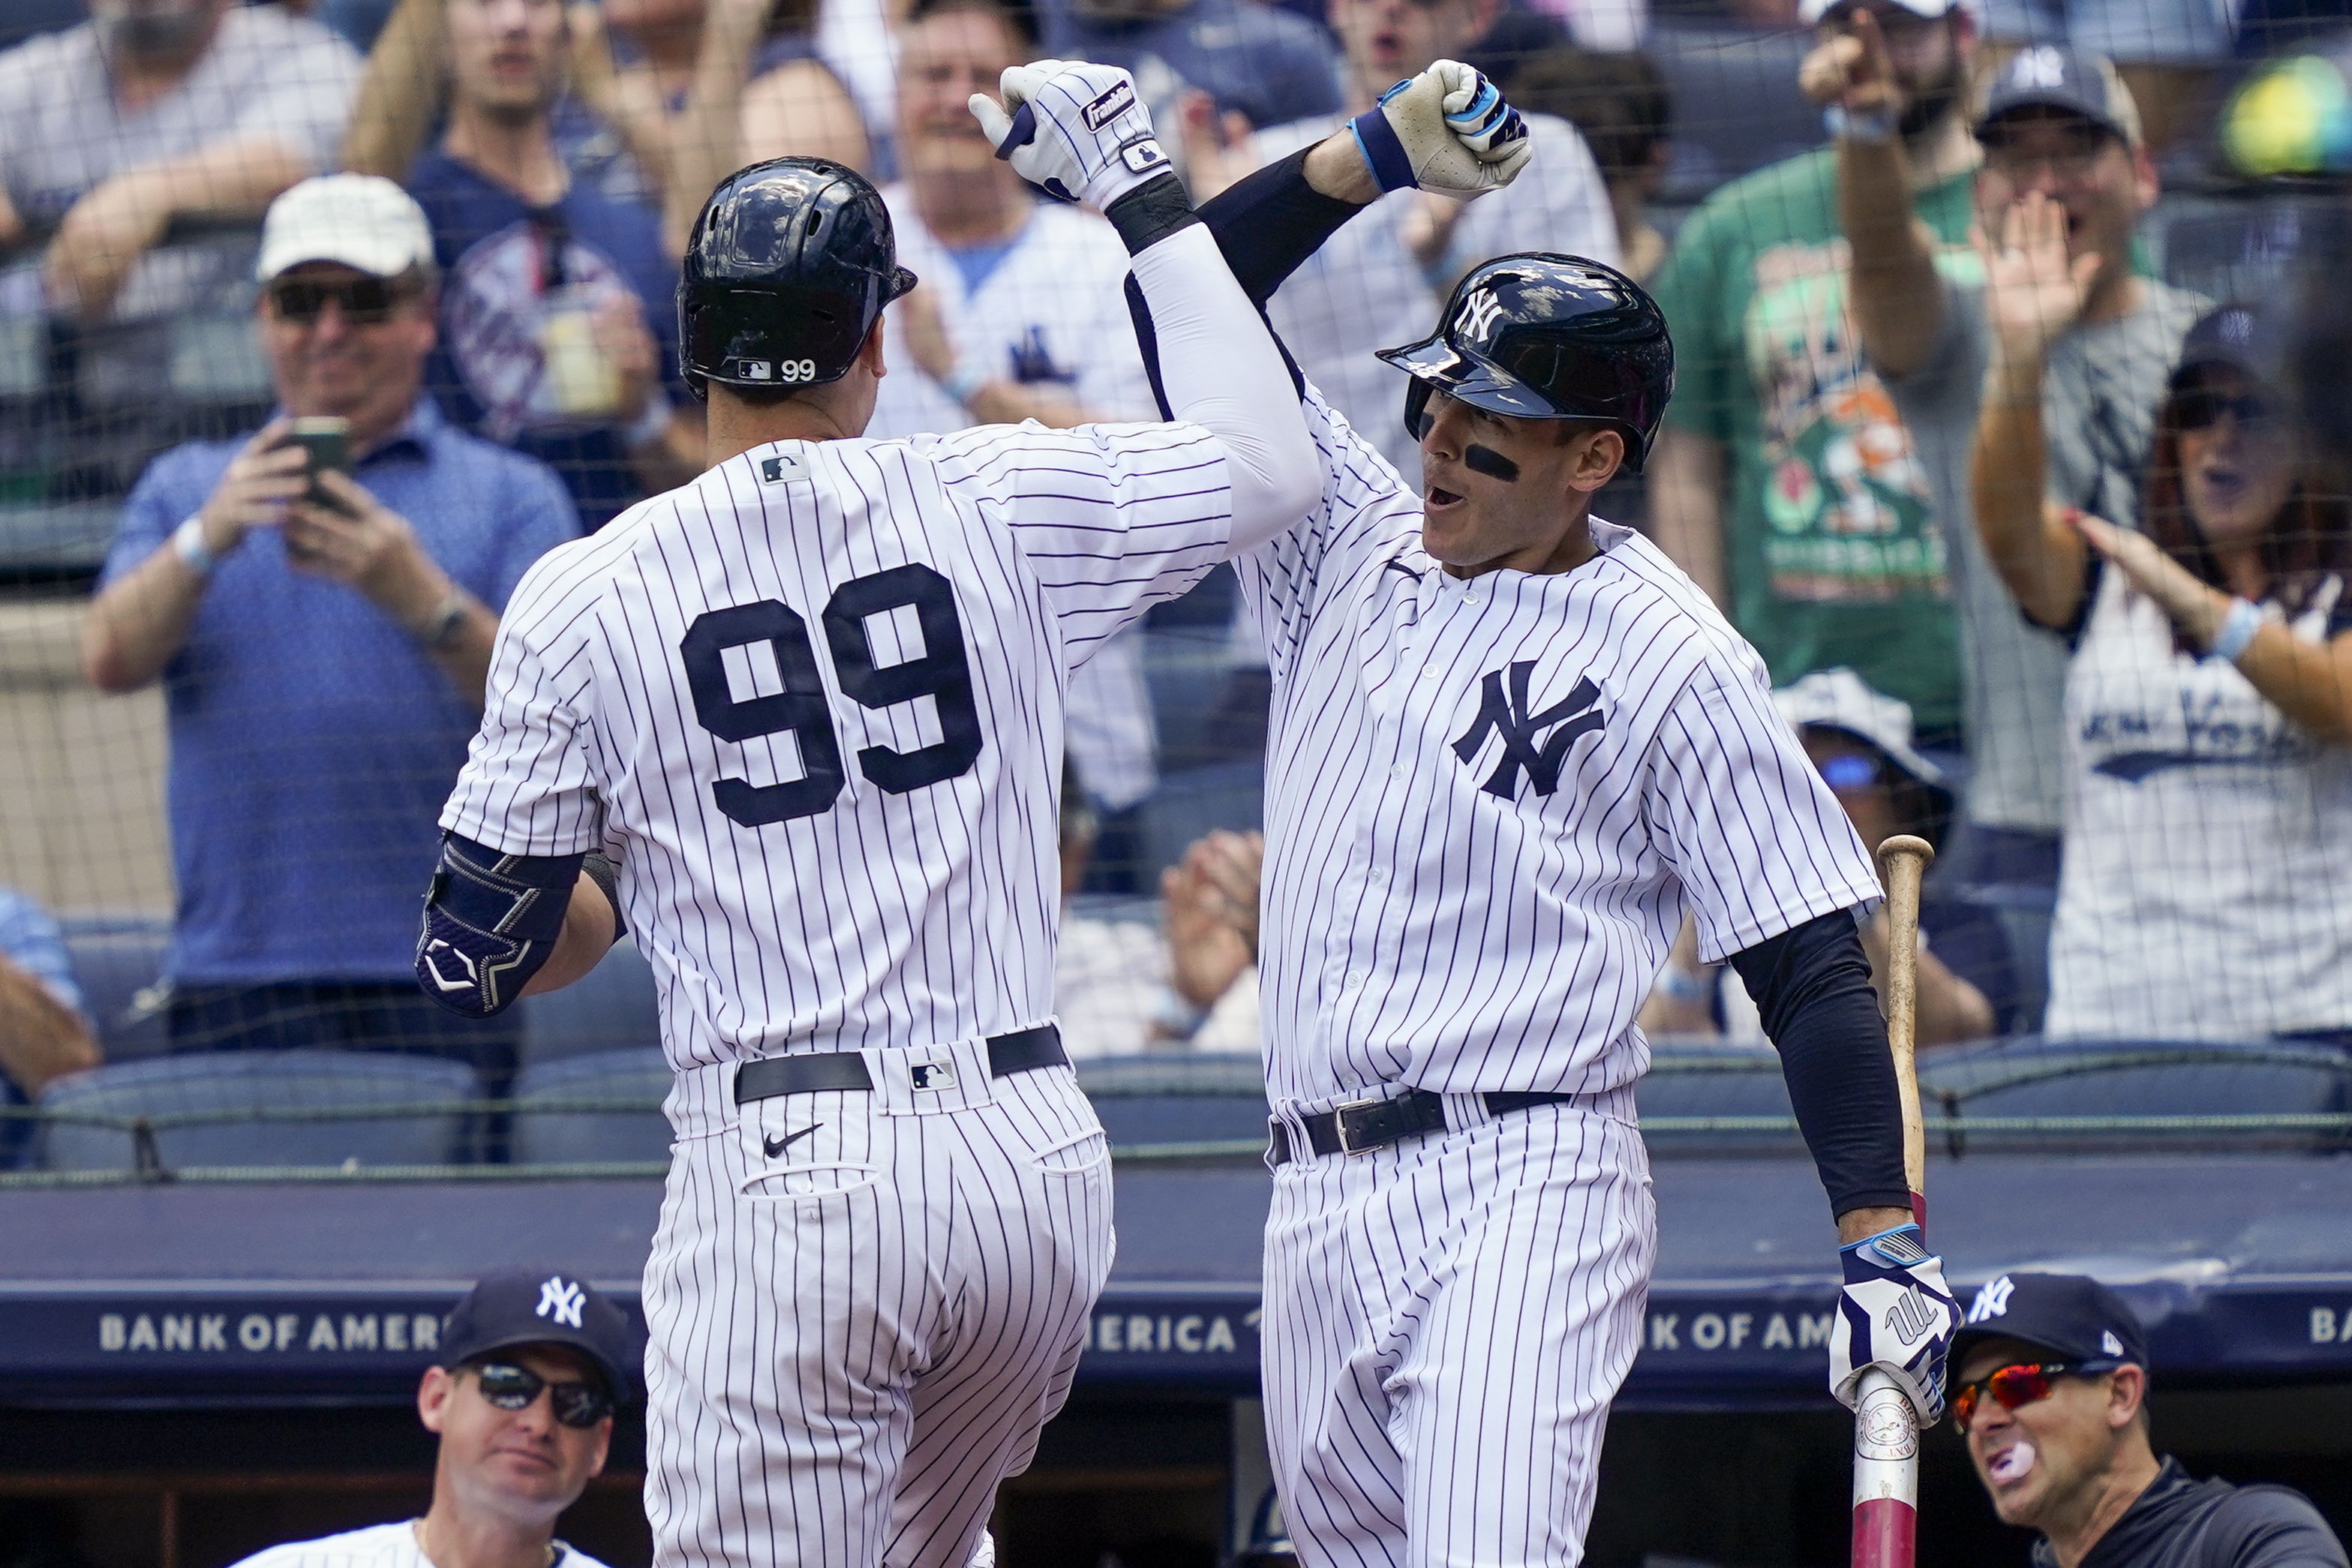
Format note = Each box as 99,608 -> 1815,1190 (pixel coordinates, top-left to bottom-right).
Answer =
644,1041 -> 1113,1568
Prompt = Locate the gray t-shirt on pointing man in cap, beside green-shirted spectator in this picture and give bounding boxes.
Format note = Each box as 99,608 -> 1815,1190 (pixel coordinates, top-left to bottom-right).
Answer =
1886,278 -> 2211,834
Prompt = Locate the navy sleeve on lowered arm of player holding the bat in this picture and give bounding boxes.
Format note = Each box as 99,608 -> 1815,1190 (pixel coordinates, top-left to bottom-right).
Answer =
1731,910 -> 1910,1215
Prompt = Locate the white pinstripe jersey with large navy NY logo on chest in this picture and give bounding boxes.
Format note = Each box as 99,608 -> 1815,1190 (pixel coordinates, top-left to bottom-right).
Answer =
1235,395 -> 1879,1100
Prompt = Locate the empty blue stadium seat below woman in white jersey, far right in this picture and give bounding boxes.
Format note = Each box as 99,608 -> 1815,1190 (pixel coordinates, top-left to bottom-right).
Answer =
1919,1037 -> 2352,1152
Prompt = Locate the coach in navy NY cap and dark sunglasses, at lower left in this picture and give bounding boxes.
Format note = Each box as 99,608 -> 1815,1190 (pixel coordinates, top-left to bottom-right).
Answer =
238,1269 -> 644,1568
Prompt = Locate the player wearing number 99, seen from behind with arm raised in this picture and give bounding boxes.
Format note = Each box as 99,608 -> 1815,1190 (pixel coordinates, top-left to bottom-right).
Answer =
416,61 -> 1524,1568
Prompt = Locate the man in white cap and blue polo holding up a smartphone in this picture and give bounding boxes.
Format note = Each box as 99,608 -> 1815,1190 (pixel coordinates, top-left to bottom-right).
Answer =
83,174 -> 578,1093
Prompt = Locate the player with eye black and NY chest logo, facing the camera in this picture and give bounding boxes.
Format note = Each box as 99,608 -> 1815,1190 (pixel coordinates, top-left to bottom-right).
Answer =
1138,83 -> 1957,1568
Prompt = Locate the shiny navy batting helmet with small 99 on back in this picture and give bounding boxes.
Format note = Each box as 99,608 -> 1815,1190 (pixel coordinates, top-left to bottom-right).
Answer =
677,158 -> 915,398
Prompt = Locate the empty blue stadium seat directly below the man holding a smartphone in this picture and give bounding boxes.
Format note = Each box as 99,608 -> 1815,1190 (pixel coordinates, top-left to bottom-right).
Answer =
38,1051 -> 480,1170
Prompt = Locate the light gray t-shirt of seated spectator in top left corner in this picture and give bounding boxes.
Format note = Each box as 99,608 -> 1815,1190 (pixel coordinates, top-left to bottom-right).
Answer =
0,5 -> 360,320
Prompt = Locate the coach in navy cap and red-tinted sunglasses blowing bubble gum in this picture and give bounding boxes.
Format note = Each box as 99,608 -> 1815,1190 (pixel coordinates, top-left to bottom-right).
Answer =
1952,1274 -> 2345,1568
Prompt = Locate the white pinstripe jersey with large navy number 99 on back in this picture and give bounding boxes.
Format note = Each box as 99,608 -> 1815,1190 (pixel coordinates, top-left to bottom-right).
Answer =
442,423 -> 1233,1070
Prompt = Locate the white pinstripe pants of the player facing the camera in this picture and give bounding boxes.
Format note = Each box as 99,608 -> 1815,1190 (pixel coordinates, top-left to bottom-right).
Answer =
1260,1089 -> 1658,1568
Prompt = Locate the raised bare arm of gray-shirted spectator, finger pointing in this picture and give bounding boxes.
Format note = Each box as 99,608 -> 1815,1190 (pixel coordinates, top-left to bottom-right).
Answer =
1799,5 -> 1943,376
